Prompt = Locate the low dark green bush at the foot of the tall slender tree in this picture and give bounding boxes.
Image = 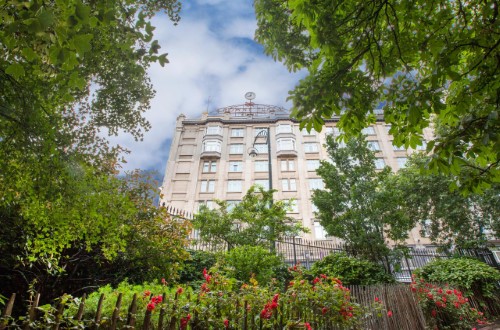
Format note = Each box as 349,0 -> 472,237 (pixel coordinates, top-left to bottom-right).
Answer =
309,253 -> 394,285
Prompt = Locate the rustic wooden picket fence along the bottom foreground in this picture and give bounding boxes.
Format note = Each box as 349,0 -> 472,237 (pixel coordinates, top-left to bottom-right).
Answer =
0,285 -> 425,330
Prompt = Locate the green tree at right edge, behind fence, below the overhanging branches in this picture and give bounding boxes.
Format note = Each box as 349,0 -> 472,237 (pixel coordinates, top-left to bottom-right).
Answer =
387,154 -> 500,248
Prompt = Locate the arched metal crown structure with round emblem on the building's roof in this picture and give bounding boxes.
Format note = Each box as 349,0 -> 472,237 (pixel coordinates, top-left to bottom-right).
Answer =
217,92 -> 288,118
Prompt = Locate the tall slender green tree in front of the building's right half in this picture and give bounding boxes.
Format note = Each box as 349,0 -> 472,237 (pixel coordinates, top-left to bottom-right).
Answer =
312,136 -> 413,260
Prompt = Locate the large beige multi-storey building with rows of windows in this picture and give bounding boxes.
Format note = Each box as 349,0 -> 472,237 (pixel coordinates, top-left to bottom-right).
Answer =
160,93 -> 432,247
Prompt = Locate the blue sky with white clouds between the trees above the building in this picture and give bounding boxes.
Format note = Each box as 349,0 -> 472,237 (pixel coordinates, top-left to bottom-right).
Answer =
113,0 -> 301,179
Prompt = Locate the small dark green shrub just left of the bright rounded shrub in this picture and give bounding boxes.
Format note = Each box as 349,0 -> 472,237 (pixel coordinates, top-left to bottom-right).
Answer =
178,251 -> 217,286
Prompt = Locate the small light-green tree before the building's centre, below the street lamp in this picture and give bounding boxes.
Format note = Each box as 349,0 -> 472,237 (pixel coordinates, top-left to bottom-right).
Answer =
193,186 -> 305,247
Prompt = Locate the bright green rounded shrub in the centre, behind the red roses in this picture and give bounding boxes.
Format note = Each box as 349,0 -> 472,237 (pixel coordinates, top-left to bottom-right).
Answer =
223,245 -> 284,285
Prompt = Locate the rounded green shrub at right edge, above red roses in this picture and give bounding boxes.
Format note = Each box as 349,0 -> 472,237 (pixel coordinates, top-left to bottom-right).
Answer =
414,258 -> 500,297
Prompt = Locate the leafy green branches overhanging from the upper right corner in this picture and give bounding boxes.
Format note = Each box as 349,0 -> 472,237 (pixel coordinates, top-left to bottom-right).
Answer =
255,0 -> 500,192
